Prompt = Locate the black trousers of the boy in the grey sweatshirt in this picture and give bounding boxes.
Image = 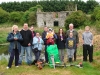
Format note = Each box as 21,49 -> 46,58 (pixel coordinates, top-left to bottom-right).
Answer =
83,45 -> 93,62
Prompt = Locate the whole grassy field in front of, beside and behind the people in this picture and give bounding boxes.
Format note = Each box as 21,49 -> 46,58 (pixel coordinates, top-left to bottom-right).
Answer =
0,26 -> 100,75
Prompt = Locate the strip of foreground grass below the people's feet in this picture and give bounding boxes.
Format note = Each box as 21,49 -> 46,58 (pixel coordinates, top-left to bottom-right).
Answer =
0,60 -> 100,75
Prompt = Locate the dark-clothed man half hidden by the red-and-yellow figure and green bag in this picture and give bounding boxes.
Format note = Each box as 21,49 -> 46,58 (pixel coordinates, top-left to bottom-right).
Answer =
42,26 -> 48,63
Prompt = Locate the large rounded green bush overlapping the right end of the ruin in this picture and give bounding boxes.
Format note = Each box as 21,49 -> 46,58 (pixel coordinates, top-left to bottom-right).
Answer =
65,11 -> 86,29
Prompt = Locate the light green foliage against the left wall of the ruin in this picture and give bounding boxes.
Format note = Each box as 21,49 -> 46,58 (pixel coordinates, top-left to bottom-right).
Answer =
22,5 -> 43,25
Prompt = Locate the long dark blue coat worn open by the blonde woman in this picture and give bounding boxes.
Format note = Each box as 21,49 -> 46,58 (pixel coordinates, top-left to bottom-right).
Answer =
7,32 -> 23,53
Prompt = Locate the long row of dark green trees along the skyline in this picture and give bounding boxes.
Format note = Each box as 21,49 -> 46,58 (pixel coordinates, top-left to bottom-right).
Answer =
0,0 -> 99,13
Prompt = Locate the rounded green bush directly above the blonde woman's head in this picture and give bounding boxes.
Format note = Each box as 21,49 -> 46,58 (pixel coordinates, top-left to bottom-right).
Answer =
9,12 -> 22,23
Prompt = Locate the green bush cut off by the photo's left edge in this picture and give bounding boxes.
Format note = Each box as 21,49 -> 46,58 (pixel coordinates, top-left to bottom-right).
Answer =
0,8 -> 9,23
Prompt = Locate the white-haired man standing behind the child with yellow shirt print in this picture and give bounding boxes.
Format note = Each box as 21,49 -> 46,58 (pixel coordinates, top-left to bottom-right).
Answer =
66,23 -> 79,61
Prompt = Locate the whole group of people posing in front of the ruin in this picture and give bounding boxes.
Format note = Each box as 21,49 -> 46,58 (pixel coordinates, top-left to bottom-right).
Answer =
7,23 -> 93,69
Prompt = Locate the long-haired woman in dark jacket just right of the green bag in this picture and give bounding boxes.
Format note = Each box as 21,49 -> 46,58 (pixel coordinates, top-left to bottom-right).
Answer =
56,28 -> 66,62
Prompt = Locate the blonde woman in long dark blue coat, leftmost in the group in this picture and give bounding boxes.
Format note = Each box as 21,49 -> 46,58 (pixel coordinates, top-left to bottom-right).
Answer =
7,25 -> 23,69
